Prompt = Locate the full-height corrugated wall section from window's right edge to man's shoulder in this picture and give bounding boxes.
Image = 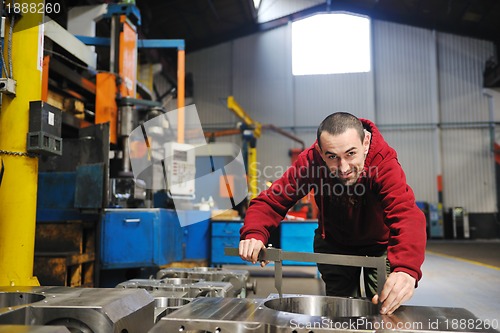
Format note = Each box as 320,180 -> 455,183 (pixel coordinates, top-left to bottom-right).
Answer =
372,21 -> 438,202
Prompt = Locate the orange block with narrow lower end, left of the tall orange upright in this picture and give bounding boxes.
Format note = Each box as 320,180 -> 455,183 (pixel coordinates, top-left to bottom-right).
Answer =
95,73 -> 118,144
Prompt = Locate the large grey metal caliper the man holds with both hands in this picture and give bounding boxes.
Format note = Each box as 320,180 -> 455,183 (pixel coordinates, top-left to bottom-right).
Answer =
224,247 -> 386,296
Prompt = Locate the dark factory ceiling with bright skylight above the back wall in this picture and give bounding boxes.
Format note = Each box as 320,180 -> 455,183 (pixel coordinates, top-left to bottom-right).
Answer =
55,0 -> 500,85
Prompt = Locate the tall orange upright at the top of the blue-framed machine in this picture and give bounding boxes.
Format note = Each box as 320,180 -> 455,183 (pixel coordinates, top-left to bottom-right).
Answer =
118,15 -> 137,98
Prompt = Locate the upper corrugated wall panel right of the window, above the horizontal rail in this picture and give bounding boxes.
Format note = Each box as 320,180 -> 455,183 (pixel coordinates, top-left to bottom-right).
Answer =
372,21 -> 433,124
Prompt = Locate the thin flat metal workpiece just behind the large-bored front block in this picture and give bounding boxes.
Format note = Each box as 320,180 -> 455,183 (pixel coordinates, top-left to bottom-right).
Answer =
116,278 -> 234,298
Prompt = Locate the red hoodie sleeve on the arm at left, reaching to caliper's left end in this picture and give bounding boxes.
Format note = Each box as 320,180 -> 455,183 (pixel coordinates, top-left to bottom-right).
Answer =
240,149 -> 312,244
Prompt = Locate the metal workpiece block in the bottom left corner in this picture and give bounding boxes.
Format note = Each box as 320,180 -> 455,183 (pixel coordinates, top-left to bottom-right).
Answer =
0,287 -> 155,333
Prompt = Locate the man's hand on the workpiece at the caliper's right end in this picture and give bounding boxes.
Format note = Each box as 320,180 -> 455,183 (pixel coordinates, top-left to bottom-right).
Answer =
372,272 -> 415,314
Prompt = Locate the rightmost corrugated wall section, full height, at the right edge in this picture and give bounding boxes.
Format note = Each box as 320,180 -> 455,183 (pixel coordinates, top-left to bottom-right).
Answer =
438,34 -> 496,212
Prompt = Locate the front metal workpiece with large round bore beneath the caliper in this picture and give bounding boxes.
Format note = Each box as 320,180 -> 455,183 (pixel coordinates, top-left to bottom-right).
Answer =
149,295 -> 497,333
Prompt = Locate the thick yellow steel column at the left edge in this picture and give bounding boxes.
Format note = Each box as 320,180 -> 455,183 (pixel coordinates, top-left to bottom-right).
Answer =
0,0 -> 44,286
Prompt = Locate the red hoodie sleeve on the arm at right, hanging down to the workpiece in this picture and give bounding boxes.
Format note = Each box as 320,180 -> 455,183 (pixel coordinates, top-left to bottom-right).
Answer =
376,157 -> 427,282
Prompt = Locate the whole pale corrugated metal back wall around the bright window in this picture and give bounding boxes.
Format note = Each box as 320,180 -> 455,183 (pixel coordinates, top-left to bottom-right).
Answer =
187,17 -> 496,212
